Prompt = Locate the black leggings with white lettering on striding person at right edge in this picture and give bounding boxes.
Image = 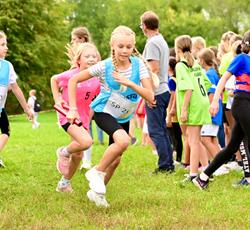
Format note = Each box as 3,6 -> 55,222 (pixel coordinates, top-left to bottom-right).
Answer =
204,92 -> 250,177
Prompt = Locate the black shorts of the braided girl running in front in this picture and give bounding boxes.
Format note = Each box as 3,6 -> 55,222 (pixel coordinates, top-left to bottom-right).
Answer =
94,112 -> 129,145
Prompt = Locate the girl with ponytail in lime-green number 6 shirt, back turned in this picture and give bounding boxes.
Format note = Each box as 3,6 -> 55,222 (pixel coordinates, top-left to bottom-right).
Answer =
175,35 -> 211,182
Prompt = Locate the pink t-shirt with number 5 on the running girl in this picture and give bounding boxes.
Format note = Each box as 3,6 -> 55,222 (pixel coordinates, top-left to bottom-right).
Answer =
56,68 -> 100,129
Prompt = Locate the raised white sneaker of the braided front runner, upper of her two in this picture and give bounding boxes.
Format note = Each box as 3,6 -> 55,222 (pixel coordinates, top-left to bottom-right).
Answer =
85,167 -> 106,194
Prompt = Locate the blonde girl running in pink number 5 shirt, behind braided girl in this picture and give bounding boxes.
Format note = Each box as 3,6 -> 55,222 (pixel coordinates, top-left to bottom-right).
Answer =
51,43 -> 100,192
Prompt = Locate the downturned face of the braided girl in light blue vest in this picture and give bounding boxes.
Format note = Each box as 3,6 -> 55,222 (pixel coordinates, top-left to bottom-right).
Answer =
111,35 -> 134,62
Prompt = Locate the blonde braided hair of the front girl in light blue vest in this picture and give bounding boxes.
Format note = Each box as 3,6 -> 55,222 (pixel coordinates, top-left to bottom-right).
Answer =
110,26 -> 159,90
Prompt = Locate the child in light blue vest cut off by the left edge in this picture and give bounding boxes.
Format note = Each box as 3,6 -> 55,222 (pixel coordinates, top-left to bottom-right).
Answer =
0,31 -> 33,167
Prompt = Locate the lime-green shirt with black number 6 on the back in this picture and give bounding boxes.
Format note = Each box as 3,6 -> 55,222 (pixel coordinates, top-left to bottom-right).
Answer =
176,60 -> 211,125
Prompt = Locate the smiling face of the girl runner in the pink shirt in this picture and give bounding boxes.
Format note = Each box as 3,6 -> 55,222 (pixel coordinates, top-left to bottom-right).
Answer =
78,48 -> 99,70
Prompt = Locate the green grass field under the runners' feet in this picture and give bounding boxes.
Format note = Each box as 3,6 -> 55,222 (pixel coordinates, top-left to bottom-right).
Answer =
0,112 -> 250,229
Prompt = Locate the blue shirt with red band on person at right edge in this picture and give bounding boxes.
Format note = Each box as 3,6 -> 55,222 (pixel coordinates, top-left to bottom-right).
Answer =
227,53 -> 250,93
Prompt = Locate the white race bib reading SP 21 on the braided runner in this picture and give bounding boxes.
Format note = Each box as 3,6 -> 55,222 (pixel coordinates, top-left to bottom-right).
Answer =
103,92 -> 138,119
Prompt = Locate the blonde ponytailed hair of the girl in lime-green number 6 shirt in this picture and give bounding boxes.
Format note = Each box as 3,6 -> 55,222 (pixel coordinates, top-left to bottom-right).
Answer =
175,35 -> 194,67
